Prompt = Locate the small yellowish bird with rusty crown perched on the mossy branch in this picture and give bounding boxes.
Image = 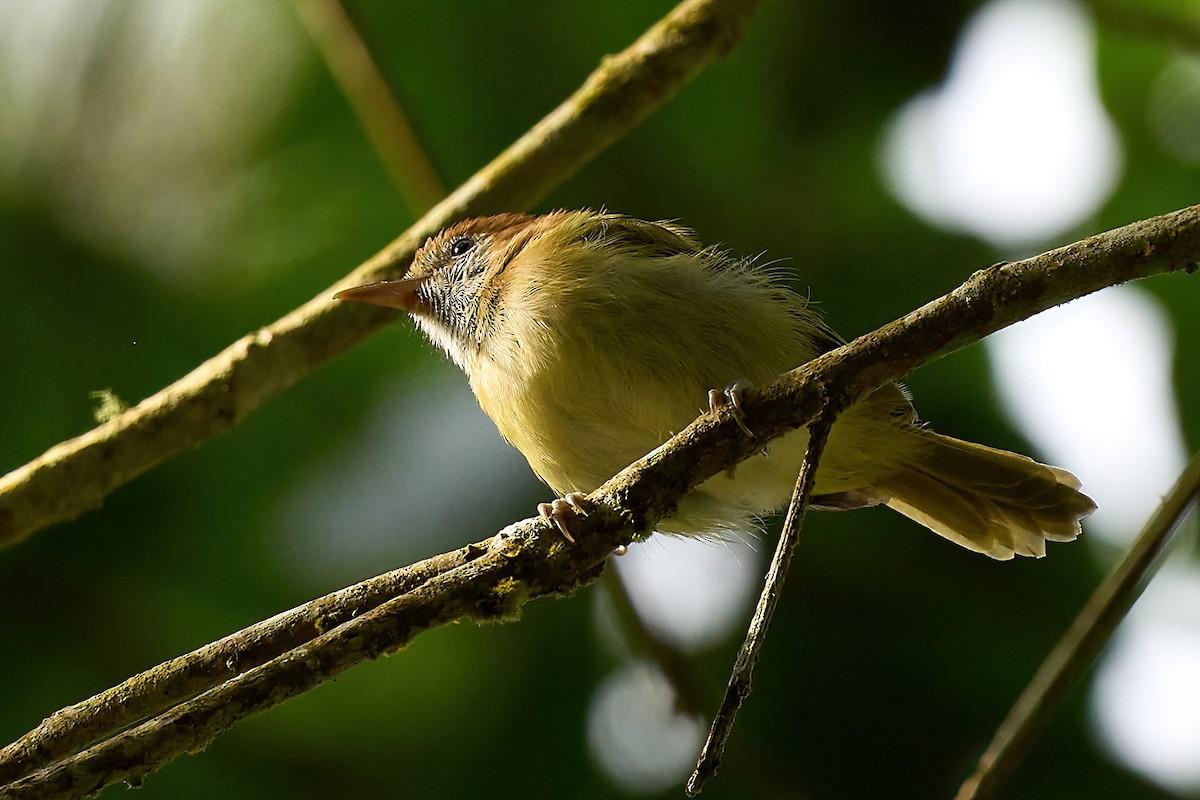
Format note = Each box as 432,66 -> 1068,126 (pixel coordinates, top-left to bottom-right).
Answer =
335,210 -> 1096,560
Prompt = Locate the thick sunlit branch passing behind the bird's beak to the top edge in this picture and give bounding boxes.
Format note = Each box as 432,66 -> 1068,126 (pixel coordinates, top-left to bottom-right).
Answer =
0,0 -> 762,547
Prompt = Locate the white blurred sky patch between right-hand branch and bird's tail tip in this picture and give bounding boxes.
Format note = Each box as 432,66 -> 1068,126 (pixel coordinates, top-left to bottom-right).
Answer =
986,287 -> 1186,547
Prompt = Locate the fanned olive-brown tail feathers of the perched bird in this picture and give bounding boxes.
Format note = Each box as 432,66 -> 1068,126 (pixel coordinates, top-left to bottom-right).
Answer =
874,428 -> 1096,560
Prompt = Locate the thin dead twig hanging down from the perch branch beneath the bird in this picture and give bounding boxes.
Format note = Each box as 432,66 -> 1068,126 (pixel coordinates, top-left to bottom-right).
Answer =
686,399 -> 841,798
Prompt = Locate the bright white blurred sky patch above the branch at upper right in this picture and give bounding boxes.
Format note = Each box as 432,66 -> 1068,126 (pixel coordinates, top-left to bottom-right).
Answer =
882,0 -> 1121,247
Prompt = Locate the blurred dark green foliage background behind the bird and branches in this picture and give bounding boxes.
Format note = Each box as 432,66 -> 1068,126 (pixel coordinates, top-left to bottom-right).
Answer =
0,0 -> 1200,800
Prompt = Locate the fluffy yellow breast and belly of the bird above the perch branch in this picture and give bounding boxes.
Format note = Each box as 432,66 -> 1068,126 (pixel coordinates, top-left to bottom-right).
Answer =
469,214 -> 814,501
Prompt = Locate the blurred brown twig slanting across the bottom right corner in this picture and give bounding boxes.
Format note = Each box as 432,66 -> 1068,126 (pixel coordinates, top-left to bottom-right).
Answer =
955,451 -> 1200,800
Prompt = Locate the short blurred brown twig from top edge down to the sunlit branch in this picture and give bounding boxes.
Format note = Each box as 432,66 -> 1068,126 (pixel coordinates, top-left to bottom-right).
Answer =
293,0 -> 446,216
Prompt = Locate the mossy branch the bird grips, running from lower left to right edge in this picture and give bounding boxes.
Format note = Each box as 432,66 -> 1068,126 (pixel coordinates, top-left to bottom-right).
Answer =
4,206 -> 1200,798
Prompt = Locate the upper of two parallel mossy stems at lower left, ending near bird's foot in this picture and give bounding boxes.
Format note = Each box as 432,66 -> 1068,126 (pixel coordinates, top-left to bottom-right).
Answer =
0,545 -> 485,786
